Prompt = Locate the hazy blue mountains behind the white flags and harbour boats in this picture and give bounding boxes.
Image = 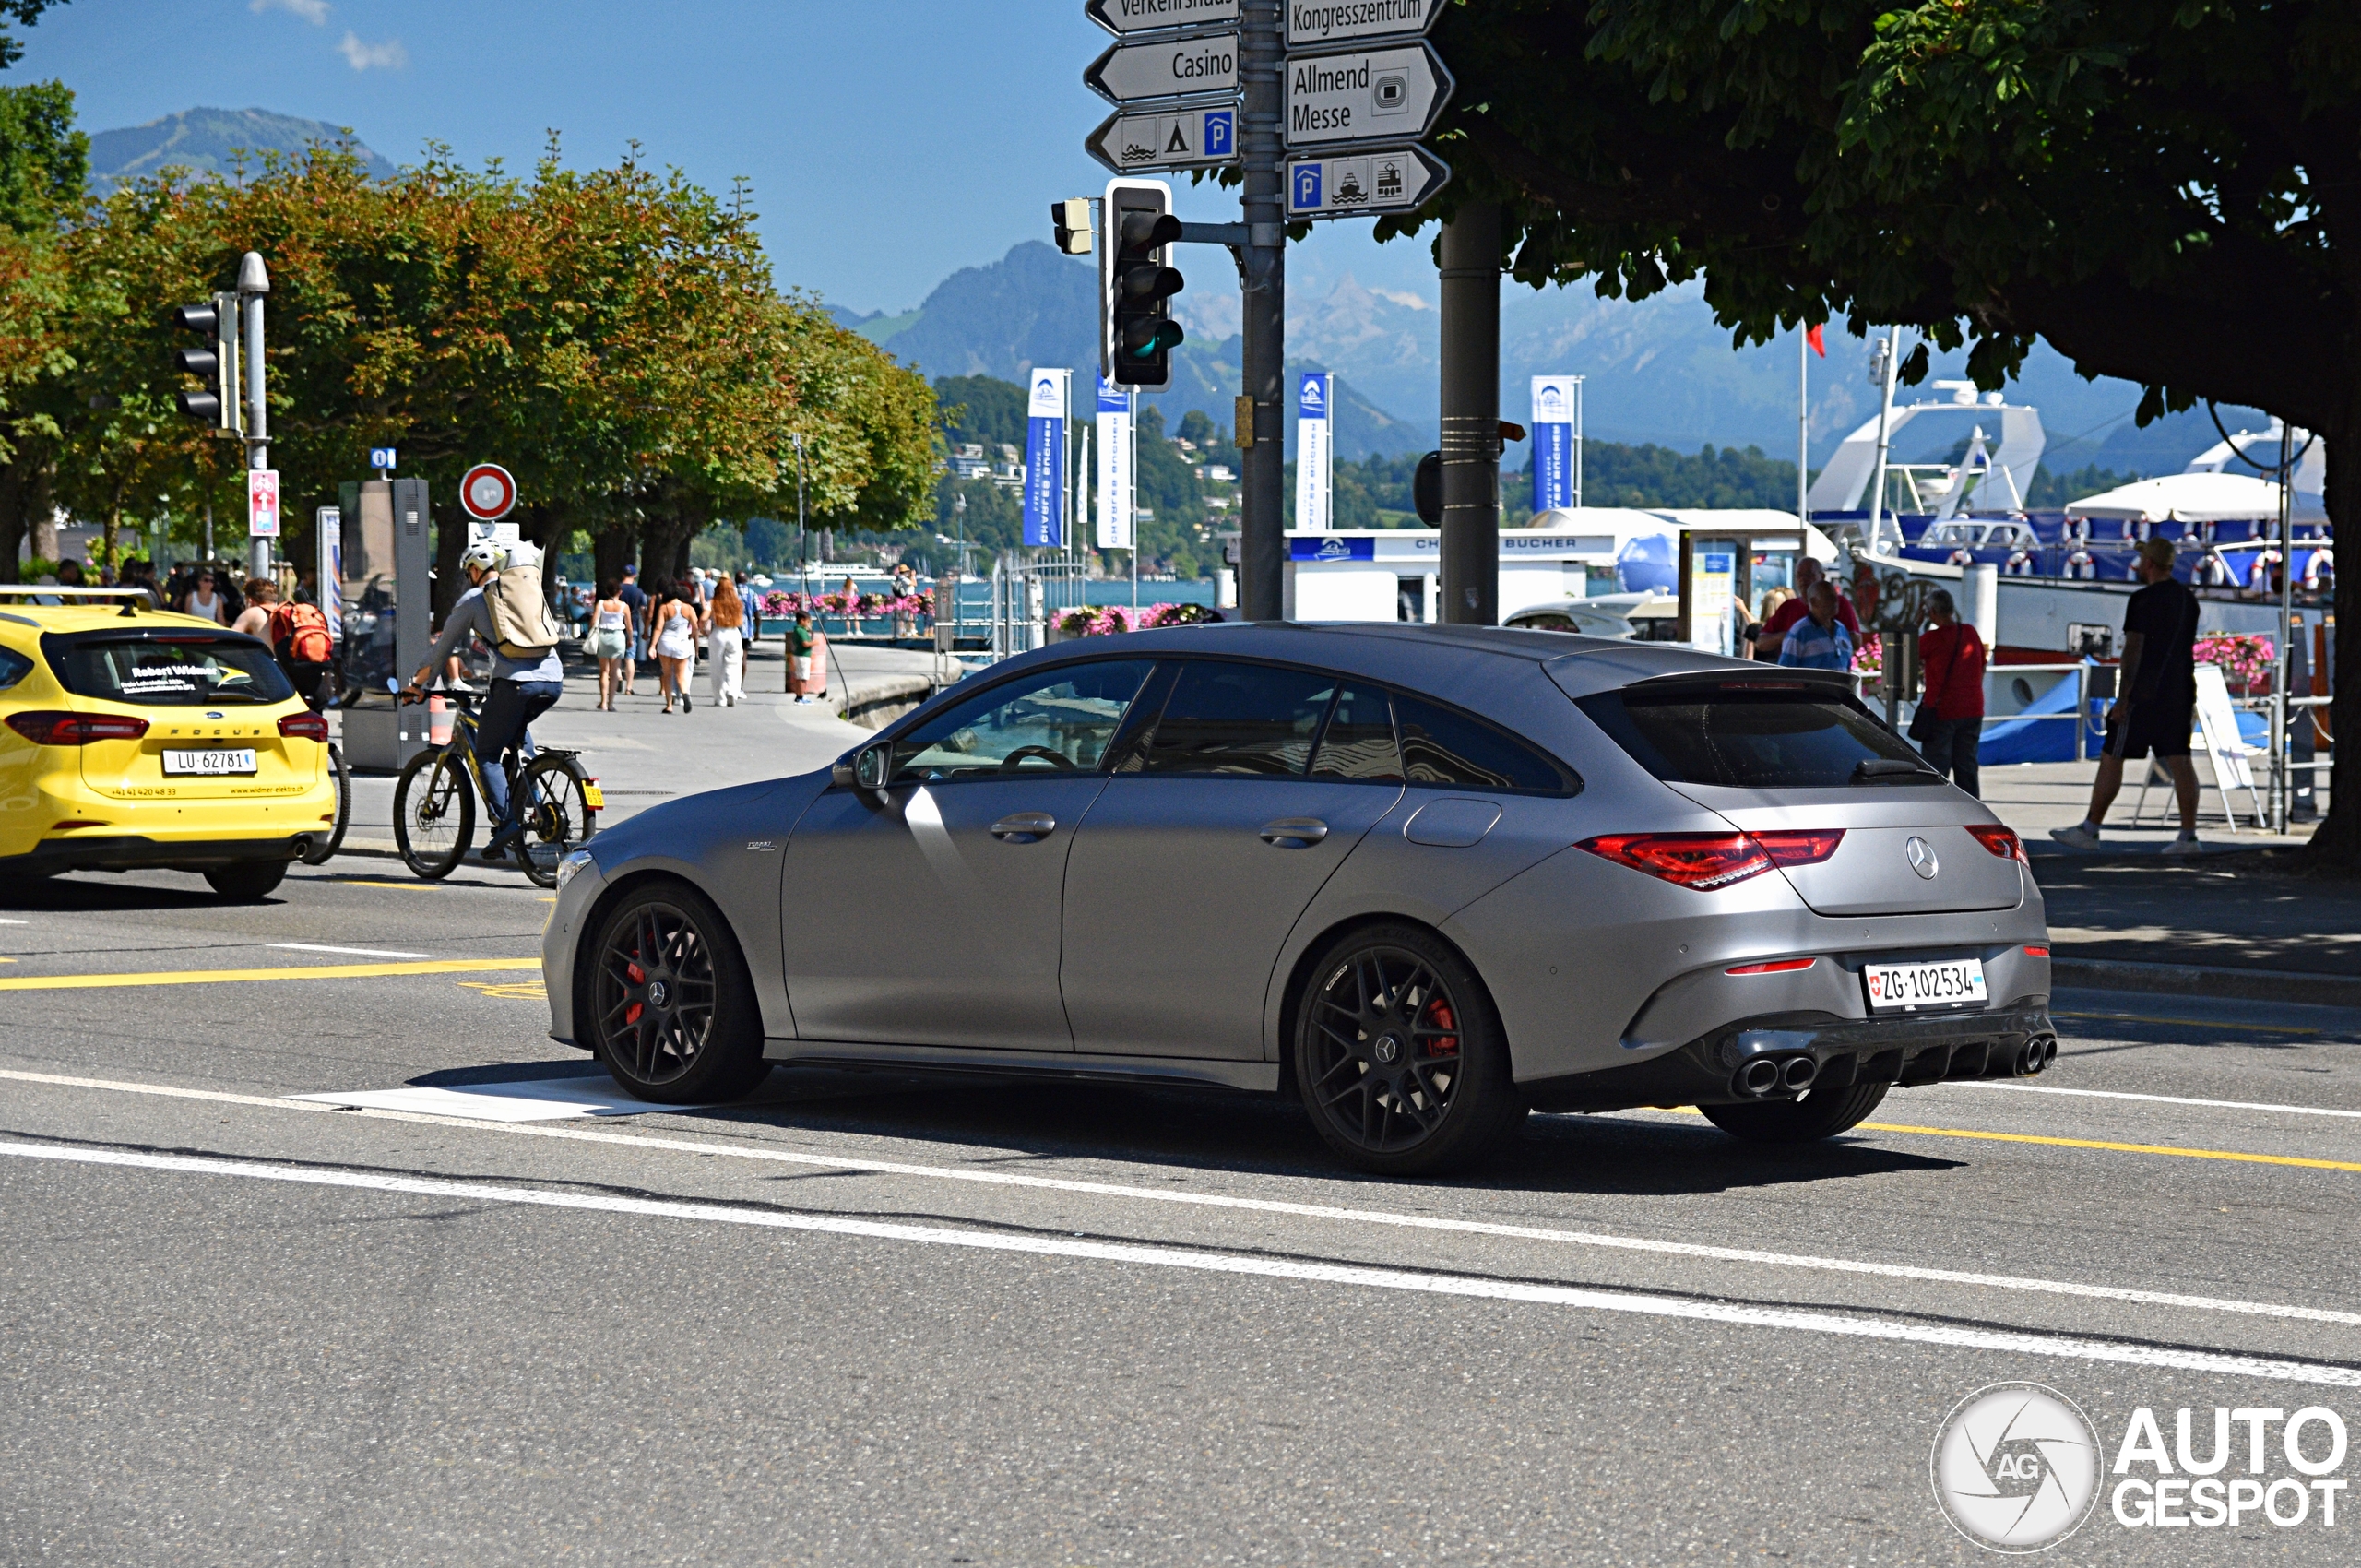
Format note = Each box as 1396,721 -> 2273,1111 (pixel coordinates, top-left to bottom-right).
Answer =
836,241 -> 2264,475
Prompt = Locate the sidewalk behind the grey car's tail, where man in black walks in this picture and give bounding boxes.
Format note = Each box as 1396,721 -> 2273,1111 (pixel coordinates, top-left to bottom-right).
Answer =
1983,763 -> 2361,1006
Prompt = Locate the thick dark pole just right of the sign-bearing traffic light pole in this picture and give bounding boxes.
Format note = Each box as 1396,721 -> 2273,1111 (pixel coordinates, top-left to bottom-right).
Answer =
1438,201 -> 1500,625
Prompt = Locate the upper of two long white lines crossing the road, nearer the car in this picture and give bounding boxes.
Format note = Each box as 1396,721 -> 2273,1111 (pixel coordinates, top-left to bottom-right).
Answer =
0,1070 -> 2361,1324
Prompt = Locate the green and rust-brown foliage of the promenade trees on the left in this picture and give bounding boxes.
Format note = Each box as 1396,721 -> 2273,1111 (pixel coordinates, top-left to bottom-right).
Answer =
25,128 -> 935,583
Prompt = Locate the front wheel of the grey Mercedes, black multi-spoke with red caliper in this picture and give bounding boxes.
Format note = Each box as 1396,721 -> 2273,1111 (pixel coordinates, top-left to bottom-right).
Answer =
578,884 -> 770,1105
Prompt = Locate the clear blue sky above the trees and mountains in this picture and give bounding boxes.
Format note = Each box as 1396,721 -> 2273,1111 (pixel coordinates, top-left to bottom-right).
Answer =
32,0 -> 1433,312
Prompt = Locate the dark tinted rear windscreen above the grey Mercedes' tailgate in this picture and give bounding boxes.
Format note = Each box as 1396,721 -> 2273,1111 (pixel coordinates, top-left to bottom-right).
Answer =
1577,683 -> 1943,789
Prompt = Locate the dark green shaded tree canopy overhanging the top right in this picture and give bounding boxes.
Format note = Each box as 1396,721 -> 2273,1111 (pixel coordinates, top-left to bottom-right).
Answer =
1391,0 -> 2361,857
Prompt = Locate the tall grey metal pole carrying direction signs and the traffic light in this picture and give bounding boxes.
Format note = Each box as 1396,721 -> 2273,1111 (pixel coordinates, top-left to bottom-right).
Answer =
1237,0 -> 1287,621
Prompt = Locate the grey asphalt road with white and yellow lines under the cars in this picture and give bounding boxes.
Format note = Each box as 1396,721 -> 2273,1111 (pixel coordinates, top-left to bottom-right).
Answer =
0,860 -> 2361,1568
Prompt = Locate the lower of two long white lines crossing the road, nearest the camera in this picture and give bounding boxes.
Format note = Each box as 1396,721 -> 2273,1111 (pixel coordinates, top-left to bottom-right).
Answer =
0,1143 -> 2361,1388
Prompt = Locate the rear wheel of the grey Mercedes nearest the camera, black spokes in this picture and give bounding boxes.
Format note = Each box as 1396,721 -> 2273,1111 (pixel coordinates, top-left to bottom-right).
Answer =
1294,926 -> 1525,1176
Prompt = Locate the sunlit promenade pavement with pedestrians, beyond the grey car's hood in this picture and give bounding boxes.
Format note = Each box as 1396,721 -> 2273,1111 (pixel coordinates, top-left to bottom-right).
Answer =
342,633 -> 949,855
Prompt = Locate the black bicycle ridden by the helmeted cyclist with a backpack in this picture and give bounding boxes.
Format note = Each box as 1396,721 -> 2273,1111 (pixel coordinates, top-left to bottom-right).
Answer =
395,692 -> 607,888
